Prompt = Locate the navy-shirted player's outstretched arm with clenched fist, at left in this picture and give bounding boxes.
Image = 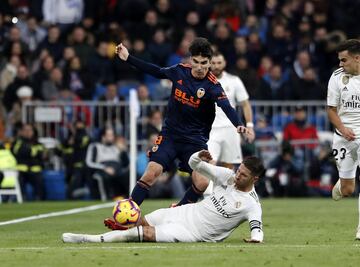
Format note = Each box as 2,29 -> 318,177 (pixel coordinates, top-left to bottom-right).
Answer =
115,44 -> 167,79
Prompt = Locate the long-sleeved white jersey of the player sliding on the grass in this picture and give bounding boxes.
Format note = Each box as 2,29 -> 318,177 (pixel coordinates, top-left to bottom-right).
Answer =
182,153 -> 263,242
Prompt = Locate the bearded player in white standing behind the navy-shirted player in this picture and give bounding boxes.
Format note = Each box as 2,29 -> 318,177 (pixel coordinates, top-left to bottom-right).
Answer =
208,52 -> 255,168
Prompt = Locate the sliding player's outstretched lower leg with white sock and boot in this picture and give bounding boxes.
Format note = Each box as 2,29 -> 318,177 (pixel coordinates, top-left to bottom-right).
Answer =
62,226 -> 156,243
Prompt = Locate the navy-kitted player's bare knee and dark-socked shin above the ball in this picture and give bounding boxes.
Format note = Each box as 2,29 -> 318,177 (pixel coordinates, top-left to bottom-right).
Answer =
131,161 -> 163,205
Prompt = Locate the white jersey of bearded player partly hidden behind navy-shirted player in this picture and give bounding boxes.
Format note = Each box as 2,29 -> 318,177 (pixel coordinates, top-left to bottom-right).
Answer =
212,71 -> 249,128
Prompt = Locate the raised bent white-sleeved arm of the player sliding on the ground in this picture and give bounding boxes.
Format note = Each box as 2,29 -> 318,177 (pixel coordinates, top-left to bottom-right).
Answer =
189,152 -> 234,185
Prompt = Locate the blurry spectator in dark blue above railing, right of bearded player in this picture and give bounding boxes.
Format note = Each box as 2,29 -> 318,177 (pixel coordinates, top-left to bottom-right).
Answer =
256,64 -> 292,100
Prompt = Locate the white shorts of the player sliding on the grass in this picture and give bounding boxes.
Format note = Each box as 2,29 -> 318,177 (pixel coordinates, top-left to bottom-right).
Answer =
145,206 -> 200,243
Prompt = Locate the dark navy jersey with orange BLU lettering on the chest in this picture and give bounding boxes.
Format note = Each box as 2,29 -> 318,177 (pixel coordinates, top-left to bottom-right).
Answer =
128,56 -> 240,143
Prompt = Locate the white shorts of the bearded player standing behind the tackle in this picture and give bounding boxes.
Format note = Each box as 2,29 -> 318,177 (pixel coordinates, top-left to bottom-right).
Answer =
207,127 -> 242,164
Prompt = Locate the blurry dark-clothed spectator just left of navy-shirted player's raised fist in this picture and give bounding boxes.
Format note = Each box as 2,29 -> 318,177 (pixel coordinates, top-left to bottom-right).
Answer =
88,41 -> 114,84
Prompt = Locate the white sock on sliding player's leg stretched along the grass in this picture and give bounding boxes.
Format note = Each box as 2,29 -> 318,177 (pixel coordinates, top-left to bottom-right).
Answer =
93,226 -> 143,243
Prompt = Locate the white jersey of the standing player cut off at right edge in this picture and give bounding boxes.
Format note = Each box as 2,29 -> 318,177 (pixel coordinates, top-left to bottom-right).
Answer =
327,68 -> 360,138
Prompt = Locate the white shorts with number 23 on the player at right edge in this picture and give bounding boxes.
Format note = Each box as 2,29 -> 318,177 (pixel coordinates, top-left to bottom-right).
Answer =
332,133 -> 360,179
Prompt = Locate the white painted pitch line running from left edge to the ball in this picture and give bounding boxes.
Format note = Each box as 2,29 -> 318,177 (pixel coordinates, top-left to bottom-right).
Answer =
0,202 -> 114,226
